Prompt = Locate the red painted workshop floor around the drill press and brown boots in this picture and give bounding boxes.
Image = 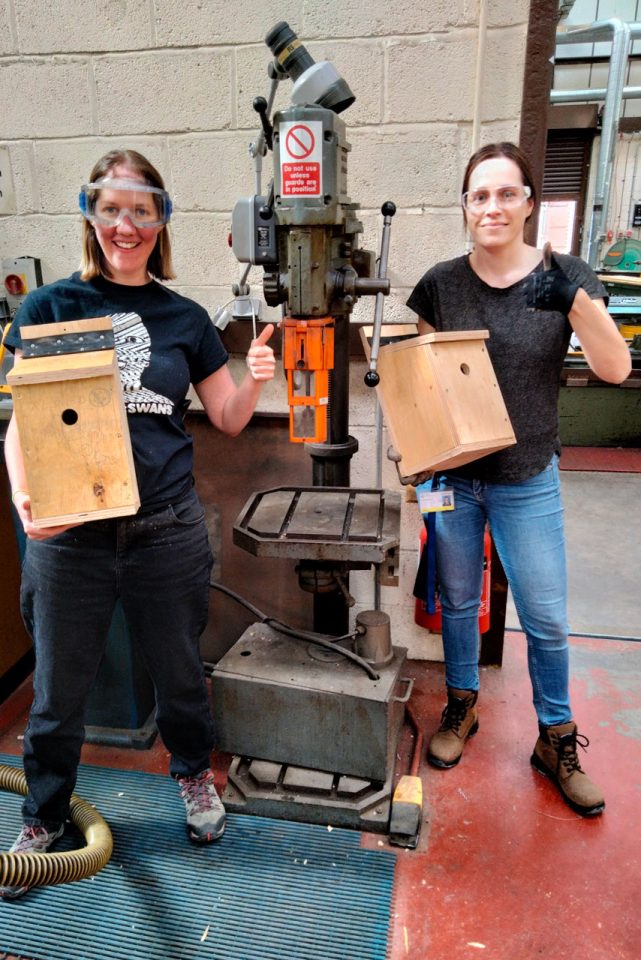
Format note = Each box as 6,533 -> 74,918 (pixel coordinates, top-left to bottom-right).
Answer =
0,633 -> 641,960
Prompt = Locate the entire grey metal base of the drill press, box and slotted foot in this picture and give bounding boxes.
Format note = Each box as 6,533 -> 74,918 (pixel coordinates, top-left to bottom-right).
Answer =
212,624 -> 412,833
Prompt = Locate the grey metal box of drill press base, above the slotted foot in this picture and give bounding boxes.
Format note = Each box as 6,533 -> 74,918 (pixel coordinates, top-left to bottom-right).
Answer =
211,623 -> 411,783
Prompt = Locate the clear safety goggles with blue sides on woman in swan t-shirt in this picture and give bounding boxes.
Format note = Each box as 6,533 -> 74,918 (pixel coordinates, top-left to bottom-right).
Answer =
78,177 -> 172,228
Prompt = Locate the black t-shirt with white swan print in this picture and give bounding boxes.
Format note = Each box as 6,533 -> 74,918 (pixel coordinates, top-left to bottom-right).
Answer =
7,273 -> 227,510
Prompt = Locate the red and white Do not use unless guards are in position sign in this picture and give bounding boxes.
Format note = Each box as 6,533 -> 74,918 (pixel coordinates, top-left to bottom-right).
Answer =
280,120 -> 323,197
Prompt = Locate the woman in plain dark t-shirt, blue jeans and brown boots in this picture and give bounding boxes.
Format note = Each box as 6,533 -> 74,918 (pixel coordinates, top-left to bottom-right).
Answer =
408,143 -> 631,816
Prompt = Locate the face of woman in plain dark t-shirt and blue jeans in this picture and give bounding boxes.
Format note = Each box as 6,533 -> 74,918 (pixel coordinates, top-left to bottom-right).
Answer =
465,157 -> 534,249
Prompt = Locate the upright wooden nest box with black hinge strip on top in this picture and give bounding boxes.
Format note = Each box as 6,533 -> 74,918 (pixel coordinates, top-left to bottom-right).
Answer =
7,317 -> 140,527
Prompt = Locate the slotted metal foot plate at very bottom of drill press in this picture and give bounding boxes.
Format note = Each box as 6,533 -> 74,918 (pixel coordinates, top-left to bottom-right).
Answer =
223,757 -> 394,833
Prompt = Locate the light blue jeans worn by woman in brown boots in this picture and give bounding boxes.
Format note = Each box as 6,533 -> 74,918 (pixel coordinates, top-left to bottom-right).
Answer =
436,456 -> 572,726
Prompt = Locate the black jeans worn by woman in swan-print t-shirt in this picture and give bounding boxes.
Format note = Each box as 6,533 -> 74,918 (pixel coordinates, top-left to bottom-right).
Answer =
21,492 -> 214,828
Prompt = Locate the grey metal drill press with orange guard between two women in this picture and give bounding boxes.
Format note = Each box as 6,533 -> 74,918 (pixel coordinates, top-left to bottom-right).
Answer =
212,22 -> 411,832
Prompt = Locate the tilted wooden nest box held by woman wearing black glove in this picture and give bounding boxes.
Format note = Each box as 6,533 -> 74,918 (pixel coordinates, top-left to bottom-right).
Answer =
361,324 -> 516,478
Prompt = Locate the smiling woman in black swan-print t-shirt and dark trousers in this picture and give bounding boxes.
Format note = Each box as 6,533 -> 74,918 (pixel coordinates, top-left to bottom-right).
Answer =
0,150 -> 275,898
